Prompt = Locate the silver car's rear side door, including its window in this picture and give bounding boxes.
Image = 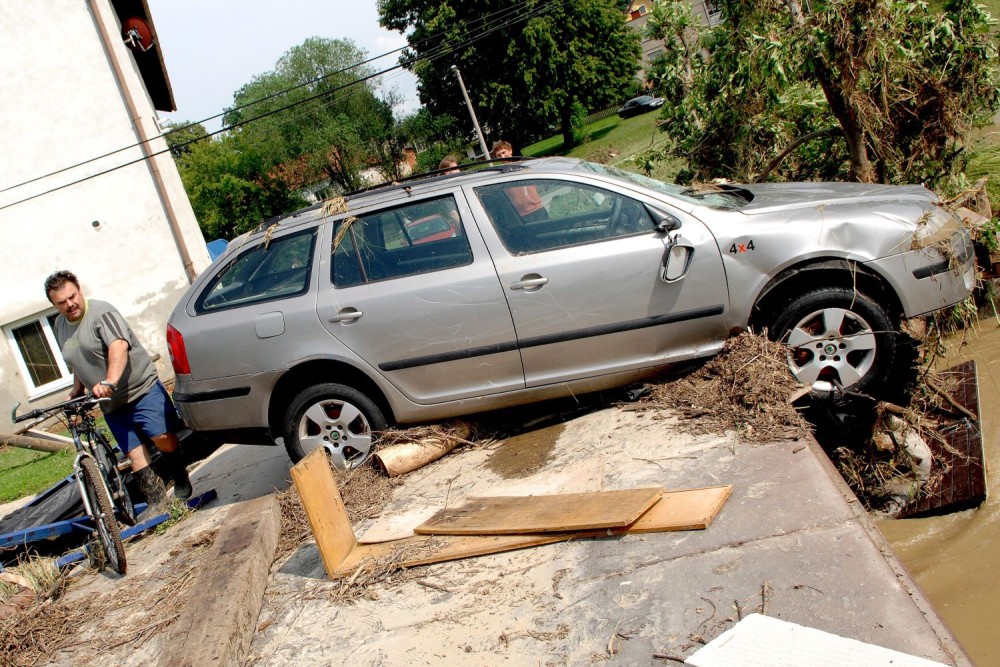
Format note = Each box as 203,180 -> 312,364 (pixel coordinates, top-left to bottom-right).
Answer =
317,190 -> 524,404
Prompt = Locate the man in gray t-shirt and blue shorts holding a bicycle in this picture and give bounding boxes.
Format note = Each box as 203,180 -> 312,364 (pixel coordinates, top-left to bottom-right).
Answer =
45,271 -> 192,507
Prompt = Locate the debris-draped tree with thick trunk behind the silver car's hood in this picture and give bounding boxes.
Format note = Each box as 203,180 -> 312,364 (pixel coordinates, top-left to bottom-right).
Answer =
644,0 -> 1000,183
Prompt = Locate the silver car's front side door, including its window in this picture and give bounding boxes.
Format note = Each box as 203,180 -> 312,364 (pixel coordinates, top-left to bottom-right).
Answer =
475,178 -> 729,387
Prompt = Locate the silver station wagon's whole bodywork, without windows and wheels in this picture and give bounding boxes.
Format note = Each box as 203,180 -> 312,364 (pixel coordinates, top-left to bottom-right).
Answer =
170,158 -> 974,437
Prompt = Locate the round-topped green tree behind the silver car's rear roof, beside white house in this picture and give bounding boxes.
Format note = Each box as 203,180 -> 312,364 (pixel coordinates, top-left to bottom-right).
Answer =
223,37 -> 402,191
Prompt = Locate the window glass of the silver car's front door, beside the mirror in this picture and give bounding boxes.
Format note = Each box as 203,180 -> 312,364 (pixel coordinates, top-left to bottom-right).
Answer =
476,179 -> 655,255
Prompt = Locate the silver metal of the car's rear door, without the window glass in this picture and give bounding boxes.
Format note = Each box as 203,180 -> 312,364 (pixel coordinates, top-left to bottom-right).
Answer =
314,193 -> 524,405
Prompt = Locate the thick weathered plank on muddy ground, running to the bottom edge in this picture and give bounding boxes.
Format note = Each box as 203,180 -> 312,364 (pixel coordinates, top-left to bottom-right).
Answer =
159,494 -> 281,667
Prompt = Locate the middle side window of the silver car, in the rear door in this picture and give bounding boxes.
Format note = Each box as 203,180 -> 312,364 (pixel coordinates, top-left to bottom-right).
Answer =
330,196 -> 472,287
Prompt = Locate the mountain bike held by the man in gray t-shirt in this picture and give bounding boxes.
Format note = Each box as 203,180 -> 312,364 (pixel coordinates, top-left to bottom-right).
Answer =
11,395 -> 136,574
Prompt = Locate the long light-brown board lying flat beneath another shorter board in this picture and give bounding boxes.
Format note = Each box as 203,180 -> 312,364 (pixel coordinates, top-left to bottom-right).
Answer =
330,486 -> 732,579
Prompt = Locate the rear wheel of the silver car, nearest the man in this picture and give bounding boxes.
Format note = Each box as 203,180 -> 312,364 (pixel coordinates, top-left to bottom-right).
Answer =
284,383 -> 386,470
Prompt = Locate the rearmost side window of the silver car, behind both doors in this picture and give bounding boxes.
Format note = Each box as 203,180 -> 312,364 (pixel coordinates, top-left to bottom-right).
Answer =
195,229 -> 316,313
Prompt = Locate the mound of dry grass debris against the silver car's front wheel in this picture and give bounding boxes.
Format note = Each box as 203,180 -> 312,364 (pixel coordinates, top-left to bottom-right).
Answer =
638,331 -> 809,443
